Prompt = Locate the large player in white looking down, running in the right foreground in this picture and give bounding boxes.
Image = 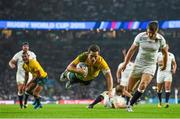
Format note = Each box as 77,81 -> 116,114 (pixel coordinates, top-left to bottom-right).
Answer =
121,21 -> 168,112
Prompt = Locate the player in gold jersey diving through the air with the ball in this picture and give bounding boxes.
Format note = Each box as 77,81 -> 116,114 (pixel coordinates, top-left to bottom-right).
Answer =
60,45 -> 113,95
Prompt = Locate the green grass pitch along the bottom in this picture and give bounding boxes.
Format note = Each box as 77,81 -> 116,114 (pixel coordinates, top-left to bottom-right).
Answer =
0,104 -> 180,118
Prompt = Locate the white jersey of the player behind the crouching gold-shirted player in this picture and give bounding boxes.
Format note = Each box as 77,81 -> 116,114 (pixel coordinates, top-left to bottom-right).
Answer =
12,50 -> 36,71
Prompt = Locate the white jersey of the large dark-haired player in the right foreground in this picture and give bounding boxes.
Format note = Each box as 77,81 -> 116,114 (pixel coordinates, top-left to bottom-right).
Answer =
133,32 -> 166,66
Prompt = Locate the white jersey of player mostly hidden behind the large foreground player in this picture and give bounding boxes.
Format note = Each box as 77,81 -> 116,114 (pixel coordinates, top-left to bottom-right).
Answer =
118,62 -> 134,80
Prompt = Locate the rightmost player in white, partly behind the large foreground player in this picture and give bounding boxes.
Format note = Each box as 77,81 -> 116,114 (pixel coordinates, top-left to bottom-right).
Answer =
156,45 -> 177,108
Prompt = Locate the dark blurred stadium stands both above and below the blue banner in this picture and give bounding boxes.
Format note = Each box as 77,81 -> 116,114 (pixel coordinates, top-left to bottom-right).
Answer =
0,0 -> 180,101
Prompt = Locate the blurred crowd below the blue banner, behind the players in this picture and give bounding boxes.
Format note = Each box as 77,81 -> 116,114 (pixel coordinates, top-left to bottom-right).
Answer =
0,30 -> 180,100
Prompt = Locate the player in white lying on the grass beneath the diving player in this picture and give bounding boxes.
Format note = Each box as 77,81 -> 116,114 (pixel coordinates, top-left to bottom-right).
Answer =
88,85 -> 127,109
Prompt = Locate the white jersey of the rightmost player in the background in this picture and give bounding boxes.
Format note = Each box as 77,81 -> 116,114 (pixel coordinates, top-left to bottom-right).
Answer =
157,52 -> 175,71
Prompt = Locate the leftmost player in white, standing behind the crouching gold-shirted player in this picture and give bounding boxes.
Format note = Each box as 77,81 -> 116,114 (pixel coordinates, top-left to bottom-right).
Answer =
9,42 -> 36,108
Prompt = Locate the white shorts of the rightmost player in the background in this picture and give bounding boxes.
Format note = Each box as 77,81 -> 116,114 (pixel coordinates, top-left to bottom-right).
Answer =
156,71 -> 172,83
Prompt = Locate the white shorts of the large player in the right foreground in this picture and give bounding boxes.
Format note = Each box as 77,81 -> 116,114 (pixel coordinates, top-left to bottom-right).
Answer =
131,65 -> 156,78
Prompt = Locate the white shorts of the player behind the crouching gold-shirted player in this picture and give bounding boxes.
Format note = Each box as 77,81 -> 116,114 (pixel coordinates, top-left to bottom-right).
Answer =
16,71 -> 32,84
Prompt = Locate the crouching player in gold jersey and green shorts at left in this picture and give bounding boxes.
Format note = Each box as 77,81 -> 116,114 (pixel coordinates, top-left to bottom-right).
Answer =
22,52 -> 48,109
